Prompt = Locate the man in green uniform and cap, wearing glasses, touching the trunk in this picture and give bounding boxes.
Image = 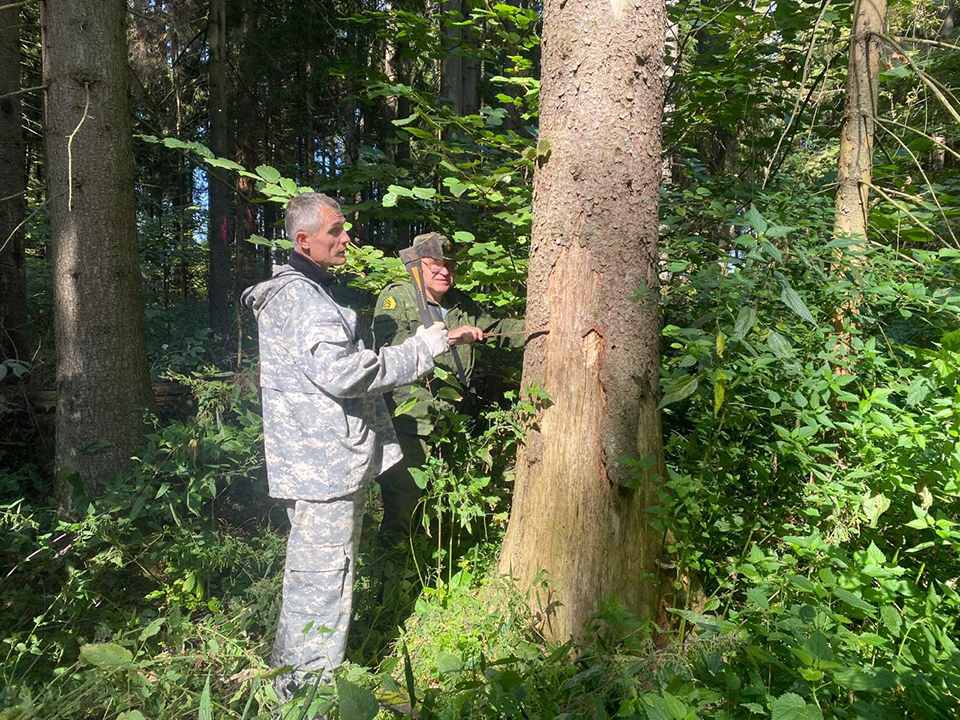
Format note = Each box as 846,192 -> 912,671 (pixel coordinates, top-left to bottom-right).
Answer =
373,233 -> 524,544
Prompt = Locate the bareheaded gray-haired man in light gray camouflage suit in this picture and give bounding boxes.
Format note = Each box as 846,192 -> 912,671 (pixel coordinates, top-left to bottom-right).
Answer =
243,193 -> 480,700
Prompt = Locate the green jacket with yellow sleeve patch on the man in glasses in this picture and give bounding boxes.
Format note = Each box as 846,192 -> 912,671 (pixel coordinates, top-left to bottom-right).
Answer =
373,283 -> 525,436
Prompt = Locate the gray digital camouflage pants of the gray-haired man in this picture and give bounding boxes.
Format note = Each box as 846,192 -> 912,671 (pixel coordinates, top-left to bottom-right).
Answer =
272,490 -> 366,699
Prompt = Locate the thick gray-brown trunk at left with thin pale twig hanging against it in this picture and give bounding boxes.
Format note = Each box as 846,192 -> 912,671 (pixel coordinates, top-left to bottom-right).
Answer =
41,0 -> 153,502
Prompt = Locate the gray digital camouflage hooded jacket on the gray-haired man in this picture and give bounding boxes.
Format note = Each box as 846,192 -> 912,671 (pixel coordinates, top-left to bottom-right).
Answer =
243,265 -> 434,501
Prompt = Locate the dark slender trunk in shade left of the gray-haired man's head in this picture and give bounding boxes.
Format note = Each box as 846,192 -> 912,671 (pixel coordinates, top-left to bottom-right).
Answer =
207,0 -> 231,339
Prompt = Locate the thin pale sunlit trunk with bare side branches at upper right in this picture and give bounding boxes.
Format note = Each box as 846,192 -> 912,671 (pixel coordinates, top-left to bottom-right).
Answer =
833,0 -> 887,338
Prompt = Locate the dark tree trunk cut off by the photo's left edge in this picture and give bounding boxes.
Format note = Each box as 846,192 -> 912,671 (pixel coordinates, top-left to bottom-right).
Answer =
0,8 -> 28,360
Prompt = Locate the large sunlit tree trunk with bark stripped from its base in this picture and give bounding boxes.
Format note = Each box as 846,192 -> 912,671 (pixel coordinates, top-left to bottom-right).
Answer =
500,0 -> 664,640
